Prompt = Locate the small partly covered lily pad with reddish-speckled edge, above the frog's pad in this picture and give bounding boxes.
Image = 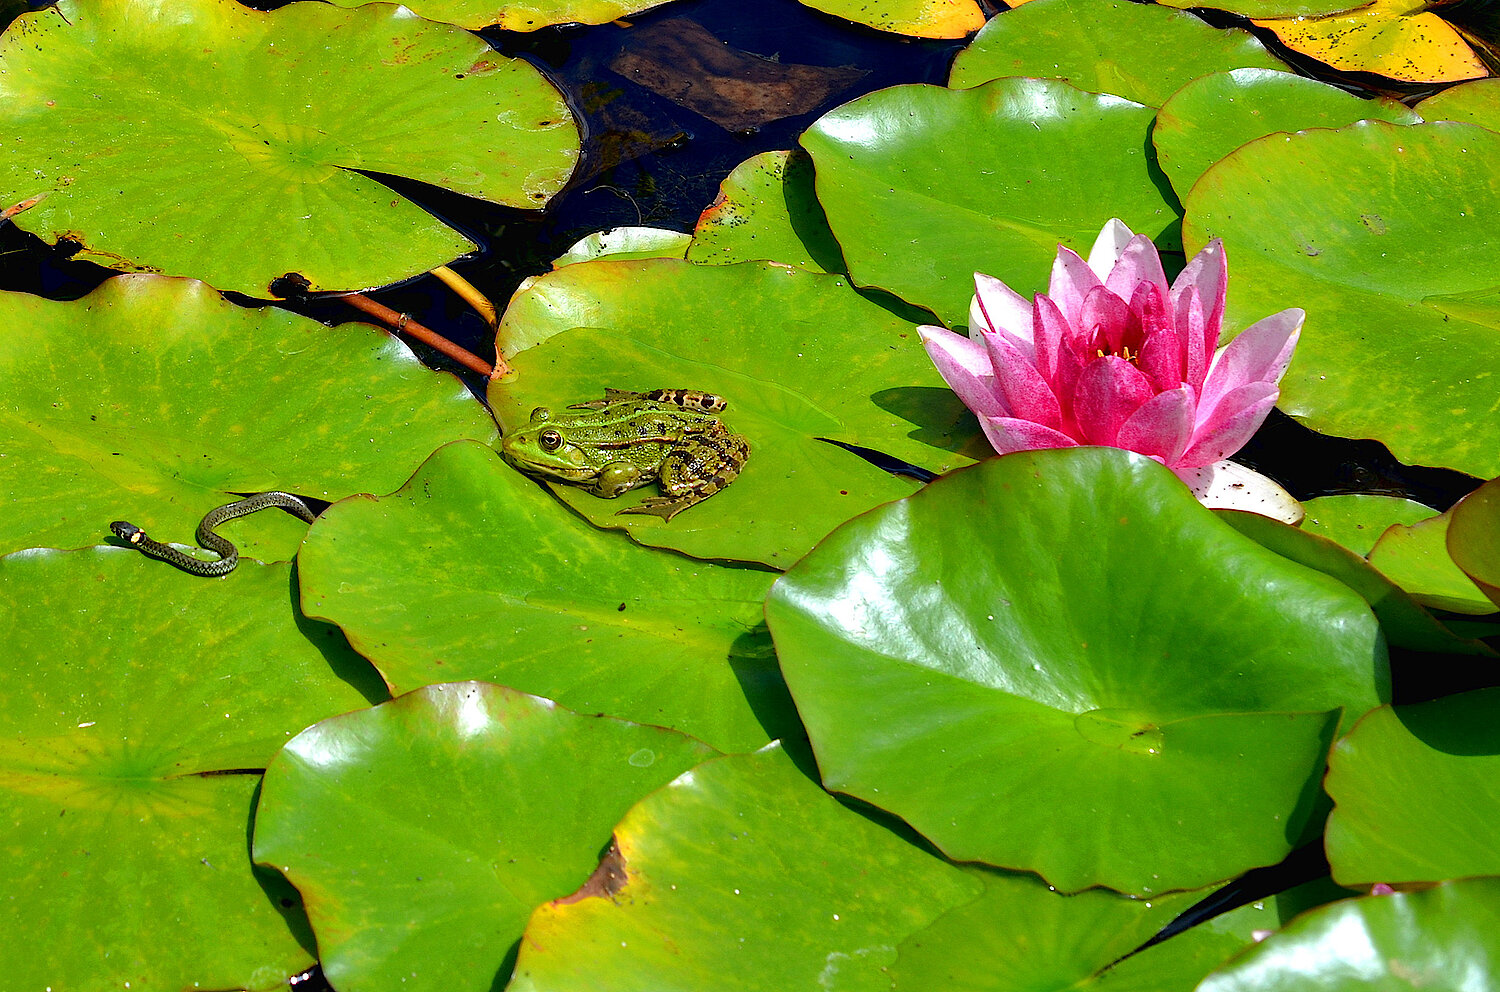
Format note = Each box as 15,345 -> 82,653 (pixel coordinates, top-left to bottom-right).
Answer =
687,149 -> 845,272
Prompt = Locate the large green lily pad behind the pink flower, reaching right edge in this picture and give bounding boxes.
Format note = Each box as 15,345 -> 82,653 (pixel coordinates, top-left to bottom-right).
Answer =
1184,122 -> 1500,479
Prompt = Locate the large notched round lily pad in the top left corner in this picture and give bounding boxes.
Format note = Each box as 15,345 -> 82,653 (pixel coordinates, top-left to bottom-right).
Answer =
0,0 -> 579,297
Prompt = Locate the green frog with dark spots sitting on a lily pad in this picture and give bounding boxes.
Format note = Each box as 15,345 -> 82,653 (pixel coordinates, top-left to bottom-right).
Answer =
501,389 -> 750,521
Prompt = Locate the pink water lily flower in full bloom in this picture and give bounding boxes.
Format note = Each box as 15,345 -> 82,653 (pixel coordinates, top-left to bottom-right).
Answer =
920,221 -> 1304,476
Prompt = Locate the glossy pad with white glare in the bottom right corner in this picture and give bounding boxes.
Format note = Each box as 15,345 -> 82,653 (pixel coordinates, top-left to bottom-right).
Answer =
1199,878 -> 1500,992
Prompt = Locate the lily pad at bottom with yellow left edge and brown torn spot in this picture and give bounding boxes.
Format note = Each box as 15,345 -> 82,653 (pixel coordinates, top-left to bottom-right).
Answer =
507,744 -> 980,992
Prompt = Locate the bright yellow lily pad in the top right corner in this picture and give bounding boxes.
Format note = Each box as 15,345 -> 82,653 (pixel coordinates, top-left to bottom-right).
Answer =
1256,0 -> 1490,83
